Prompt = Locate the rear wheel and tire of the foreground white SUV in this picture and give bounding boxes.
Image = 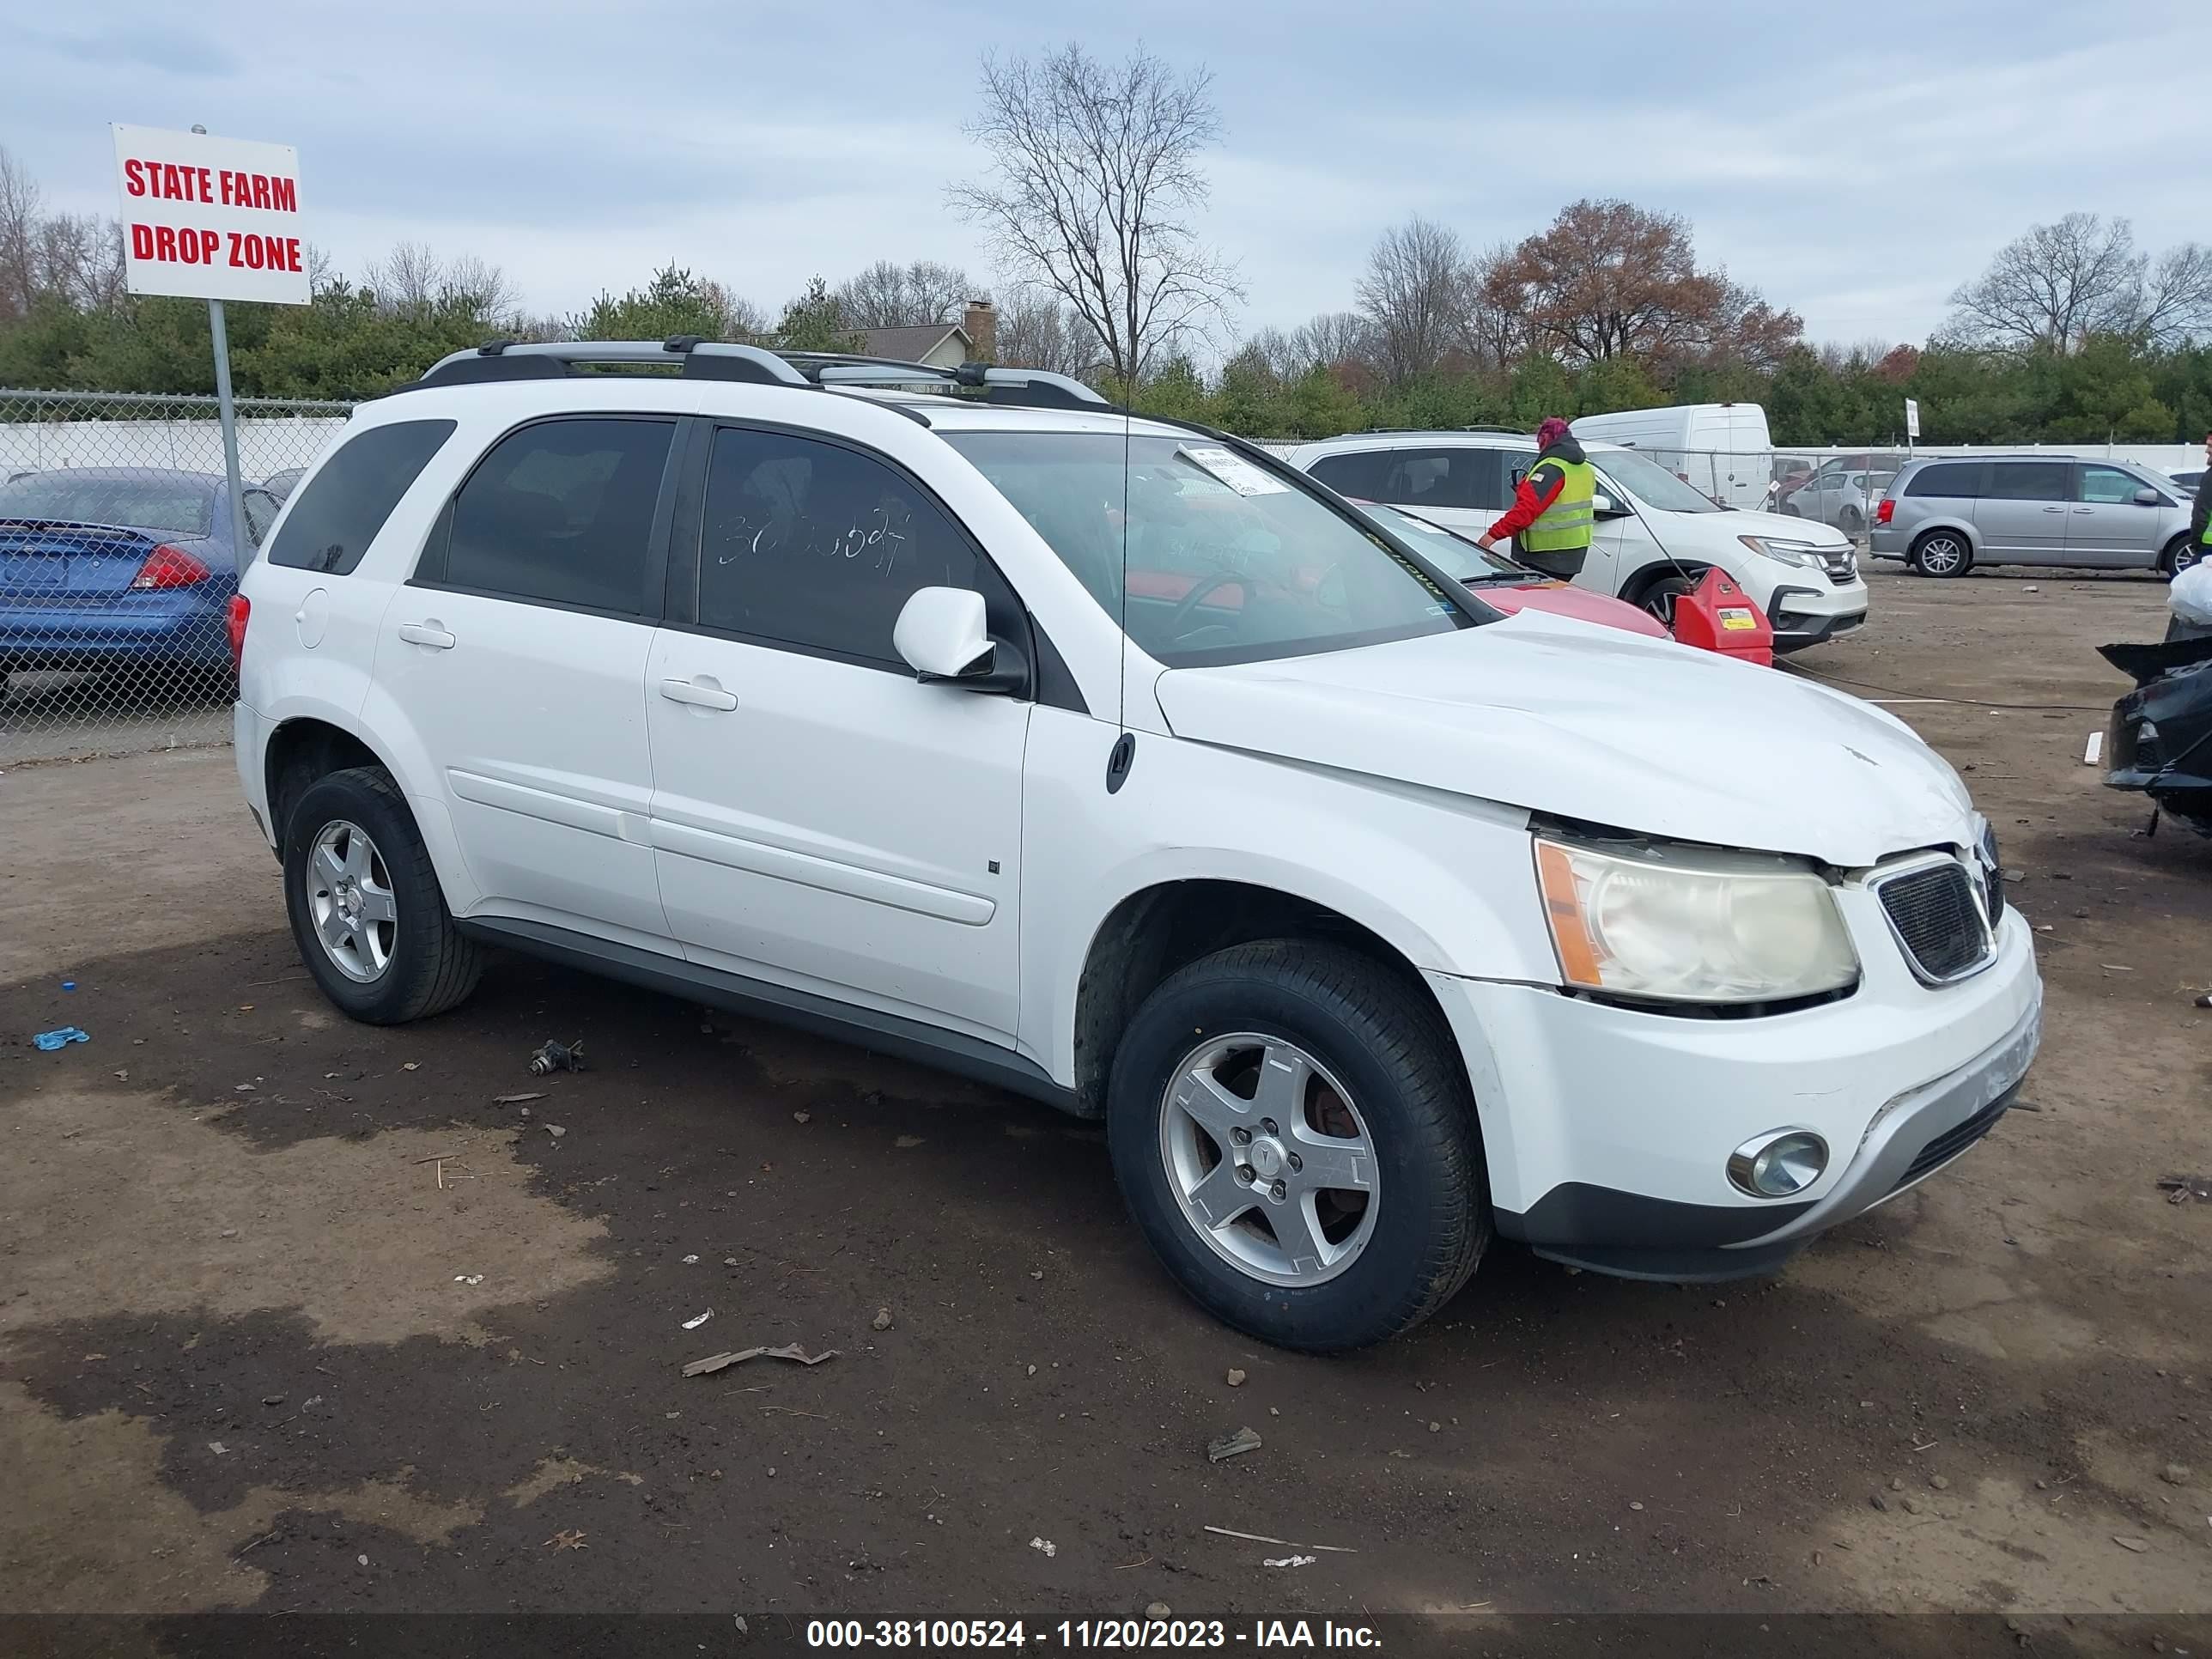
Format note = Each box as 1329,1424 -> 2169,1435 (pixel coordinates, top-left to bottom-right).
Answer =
283,765 -> 483,1026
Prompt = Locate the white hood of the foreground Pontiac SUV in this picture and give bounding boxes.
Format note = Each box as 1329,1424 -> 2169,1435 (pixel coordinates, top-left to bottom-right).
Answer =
1157,610 -> 1973,867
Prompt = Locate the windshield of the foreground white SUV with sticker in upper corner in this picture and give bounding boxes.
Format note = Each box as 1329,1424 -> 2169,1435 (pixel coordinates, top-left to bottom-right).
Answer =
945,431 -> 1474,668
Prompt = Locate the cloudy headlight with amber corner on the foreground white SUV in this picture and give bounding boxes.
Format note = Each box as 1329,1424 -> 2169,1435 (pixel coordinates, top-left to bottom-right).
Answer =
1535,836 -> 1858,1002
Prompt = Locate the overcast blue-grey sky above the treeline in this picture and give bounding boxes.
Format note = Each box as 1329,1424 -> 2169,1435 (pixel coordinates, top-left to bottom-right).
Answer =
0,0 -> 2212,343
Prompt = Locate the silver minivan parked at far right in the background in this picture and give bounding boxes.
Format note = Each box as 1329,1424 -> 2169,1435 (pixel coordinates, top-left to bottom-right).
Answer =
1869,456 -> 2197,575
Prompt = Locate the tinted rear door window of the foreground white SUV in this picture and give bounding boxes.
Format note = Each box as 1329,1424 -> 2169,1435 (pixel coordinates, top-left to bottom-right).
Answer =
442,420 -> 677,615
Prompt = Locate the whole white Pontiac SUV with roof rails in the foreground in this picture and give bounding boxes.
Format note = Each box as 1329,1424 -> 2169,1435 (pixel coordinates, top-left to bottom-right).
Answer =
232,341 -> 2042,1349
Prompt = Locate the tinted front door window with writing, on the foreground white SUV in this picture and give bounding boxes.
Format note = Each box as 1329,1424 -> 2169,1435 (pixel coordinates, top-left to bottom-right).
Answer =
699,427 -> 1000,672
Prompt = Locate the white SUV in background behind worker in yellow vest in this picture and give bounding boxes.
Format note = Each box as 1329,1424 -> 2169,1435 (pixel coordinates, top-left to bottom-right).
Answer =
1290,429 -> 1867,653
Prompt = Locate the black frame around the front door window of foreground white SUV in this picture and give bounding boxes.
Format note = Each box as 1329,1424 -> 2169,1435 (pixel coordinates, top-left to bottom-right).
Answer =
661,416 -> 1091,714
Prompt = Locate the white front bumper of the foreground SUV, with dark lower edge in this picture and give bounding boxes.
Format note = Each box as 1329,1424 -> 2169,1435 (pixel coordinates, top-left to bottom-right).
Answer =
1429,911 -> 2042,1281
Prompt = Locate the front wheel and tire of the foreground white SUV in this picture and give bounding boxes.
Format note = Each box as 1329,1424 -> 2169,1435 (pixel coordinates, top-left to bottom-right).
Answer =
1106,940 -> 1491,1354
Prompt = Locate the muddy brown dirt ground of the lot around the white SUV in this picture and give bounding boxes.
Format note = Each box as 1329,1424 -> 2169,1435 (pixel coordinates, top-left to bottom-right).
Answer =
0,571 -> 2212,1652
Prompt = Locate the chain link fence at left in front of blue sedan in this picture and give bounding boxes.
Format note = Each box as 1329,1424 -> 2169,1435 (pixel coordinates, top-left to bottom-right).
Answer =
0,389 -> 347,765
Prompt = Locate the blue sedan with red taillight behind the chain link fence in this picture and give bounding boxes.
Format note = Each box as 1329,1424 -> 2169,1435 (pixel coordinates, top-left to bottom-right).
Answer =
0,467 -> 279,686
